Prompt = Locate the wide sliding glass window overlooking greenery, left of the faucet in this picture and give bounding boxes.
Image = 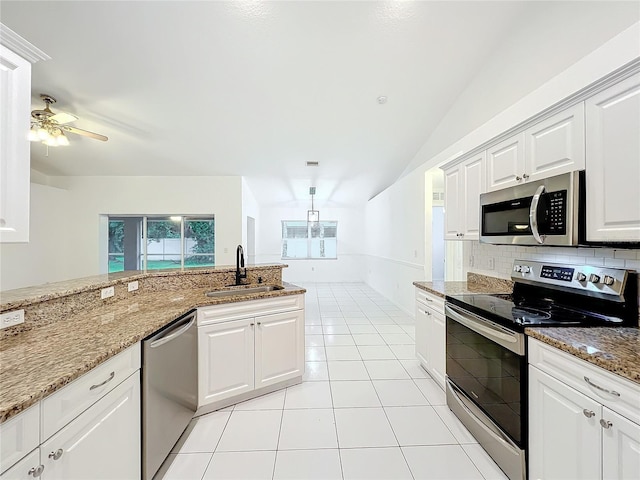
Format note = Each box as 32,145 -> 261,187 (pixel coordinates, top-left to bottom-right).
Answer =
108,215 -> 215,273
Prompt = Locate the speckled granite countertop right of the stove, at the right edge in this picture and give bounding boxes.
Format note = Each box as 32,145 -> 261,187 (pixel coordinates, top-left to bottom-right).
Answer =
525,327 -> 640,383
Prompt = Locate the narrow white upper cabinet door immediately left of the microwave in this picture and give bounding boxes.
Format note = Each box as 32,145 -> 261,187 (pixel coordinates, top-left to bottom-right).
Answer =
460,152 -> 486,240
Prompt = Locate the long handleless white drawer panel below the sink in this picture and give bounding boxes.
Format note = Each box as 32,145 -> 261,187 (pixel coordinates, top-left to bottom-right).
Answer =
198,295 -> 304,326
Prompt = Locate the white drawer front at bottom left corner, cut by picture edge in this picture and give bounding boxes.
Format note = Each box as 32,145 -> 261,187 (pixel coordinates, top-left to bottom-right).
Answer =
0,404 -> 40,473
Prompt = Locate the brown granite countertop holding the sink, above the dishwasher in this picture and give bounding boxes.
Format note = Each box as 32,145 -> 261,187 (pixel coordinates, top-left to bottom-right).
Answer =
0,283 -> 306,423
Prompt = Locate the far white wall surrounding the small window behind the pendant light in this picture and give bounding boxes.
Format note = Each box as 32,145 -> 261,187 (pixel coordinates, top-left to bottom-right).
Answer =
256,201 -> 364,283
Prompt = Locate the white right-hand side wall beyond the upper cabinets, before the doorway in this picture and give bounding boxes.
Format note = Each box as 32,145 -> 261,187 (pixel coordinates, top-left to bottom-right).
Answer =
363,169 -> 431,313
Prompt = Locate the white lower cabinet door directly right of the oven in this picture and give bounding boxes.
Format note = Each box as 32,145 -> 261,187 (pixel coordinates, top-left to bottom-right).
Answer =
529,366 -> 602,480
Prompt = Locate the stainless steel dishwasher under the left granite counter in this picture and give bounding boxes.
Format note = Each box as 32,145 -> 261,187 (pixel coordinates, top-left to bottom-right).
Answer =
142,311 -> 198,480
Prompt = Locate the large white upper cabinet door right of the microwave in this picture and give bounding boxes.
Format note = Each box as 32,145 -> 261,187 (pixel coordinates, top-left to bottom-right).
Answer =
585,74 -> 640,242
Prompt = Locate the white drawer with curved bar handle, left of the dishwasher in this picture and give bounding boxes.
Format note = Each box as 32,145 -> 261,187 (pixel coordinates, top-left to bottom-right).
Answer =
42,343 -> 140,441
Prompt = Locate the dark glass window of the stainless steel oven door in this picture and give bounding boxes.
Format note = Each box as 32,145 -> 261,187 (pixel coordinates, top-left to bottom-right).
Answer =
446,318 -> 526,446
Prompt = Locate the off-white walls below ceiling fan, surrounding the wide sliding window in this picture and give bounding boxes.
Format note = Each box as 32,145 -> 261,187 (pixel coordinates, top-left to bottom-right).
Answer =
0,177 -> 243,290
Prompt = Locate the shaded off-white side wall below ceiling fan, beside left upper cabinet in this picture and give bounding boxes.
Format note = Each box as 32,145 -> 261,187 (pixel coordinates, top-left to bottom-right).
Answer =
0,183 -> 75,290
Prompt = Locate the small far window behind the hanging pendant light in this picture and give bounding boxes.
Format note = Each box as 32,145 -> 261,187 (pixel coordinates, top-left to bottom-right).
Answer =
282,220 -> 338,259
